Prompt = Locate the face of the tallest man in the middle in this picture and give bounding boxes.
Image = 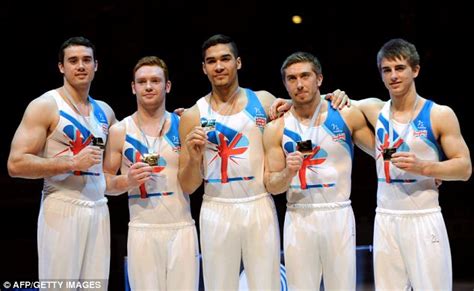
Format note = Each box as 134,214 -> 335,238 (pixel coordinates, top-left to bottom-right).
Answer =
202,44 -> 242,87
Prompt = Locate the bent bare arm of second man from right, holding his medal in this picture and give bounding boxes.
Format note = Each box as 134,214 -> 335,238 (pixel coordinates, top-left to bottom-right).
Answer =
263,118 -> 303,194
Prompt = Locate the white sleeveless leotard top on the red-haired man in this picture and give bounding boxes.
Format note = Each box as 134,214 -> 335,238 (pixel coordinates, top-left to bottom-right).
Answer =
121,114 -> 193,224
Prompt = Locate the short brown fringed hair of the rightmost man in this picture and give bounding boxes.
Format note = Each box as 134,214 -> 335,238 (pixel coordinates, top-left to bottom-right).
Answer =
377,38 -> 420,70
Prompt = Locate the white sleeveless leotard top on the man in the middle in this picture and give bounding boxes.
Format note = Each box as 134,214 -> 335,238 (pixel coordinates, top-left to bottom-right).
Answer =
197,90 -> 266,198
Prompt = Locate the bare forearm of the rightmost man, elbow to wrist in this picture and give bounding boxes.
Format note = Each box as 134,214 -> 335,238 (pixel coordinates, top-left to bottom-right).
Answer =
422,158 -> 472,181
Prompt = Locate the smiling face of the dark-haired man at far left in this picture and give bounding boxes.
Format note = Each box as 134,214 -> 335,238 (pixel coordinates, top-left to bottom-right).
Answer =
58,45 -> 97,87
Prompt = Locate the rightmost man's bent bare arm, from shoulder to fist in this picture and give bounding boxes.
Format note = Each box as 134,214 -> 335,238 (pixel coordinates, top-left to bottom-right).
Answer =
391,105 -> 472,181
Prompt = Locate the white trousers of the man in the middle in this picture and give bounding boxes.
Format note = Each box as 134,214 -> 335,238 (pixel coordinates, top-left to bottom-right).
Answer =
200,193 -> 280,291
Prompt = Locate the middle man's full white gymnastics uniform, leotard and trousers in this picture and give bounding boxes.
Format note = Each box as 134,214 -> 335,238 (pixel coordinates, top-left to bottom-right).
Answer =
197,89 -> 280,290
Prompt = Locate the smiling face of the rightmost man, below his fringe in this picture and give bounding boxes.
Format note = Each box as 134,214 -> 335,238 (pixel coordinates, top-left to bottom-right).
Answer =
380,58 -> 420,97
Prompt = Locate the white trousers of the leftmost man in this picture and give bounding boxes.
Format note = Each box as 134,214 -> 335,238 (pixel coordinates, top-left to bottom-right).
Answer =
38,194 -> 110,290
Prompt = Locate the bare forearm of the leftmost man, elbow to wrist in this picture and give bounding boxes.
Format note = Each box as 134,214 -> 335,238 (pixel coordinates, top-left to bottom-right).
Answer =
8,154 -> 74,179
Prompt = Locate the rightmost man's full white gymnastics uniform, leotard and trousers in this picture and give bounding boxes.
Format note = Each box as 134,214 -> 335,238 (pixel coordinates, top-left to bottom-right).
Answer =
374,100 -> 452,290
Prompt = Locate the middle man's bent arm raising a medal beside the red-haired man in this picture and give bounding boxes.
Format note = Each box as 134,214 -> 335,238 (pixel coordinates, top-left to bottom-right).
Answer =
178,105 -> 207,194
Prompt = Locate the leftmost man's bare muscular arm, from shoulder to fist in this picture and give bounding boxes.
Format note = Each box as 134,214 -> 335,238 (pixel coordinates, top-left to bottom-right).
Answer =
8,96 -> 102,179
